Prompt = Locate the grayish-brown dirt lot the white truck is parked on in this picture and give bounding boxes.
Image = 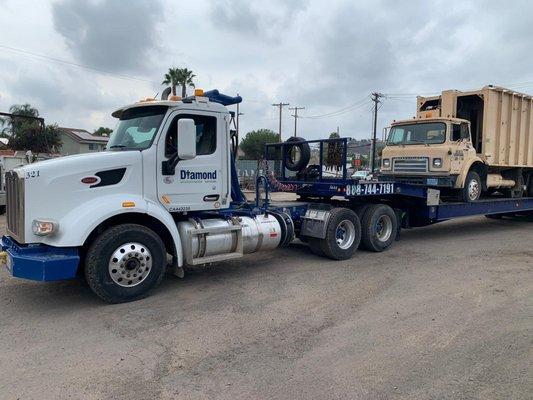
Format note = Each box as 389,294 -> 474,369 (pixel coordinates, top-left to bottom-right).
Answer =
0,211 -> 533,400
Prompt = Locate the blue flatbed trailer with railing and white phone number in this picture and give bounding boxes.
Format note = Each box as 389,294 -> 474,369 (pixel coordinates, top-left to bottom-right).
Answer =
262,138 -> 533,227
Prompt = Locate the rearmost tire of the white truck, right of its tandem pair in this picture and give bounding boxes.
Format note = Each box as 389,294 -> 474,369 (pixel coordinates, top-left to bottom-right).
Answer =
361,204 -> 398,252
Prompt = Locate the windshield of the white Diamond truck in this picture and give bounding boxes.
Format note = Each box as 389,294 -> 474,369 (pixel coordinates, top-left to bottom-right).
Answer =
106,106 -> 168,151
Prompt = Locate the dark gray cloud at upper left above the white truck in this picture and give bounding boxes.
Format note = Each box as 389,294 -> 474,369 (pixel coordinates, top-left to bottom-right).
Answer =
52,0 -> 163,72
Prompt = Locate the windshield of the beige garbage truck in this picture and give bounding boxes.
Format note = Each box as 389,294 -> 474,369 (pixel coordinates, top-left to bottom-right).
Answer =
387,122 -> 446,145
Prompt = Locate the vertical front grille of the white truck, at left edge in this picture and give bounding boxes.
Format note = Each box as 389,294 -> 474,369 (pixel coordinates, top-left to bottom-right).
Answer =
5,171 -> 24,243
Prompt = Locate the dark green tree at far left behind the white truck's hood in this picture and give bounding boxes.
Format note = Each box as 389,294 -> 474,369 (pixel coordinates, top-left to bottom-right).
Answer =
9,104 -> 61,153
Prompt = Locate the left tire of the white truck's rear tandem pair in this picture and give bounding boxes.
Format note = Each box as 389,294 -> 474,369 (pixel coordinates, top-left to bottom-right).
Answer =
319,208 -> 361,260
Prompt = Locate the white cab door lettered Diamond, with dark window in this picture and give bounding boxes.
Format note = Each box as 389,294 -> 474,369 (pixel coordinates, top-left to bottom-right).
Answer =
157,110 -> 227,212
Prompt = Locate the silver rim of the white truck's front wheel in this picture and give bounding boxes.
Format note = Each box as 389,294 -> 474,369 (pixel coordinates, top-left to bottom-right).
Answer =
108,243 -> 152,287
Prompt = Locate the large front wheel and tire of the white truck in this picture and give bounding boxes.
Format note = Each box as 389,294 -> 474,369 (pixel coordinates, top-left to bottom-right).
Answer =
85,224 -> 166,303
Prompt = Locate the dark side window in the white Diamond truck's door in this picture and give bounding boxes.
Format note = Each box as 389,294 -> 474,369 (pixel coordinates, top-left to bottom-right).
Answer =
165,114 -> 217,157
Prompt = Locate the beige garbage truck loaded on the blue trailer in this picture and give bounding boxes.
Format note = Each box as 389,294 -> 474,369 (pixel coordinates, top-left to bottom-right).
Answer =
381,86 -> 533,201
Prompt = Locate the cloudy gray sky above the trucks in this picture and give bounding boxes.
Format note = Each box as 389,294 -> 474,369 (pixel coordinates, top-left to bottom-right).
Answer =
0,0 -> 533,139
